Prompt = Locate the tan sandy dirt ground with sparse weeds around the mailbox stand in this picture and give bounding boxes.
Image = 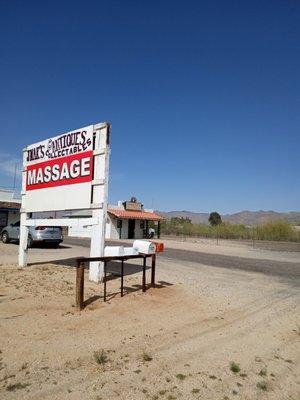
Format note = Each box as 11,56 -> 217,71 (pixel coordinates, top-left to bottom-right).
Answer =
0,244 -> 300,400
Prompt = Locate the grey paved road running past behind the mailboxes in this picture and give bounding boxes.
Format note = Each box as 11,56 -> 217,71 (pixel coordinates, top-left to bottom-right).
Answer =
64,238 -> 300,284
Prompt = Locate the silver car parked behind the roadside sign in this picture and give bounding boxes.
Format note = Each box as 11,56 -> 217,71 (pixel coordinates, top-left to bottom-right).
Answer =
1,221 -> 63,247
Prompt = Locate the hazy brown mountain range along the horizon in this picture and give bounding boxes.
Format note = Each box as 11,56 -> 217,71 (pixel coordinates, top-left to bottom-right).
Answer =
156,210 -> 300,225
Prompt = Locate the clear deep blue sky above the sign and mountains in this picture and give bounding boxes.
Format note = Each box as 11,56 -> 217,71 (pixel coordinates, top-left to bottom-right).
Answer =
0,0 -> 300,213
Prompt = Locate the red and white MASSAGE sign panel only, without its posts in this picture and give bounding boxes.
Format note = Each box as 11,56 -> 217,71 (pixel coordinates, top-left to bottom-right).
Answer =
22,125 -> 93,212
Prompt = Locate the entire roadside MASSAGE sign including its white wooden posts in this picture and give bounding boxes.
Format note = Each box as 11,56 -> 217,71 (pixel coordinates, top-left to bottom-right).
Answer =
19,122 -> 110,282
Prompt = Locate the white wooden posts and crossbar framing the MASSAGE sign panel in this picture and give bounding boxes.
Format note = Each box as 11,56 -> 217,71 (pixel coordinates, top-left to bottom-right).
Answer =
19,122 -> 110,282
